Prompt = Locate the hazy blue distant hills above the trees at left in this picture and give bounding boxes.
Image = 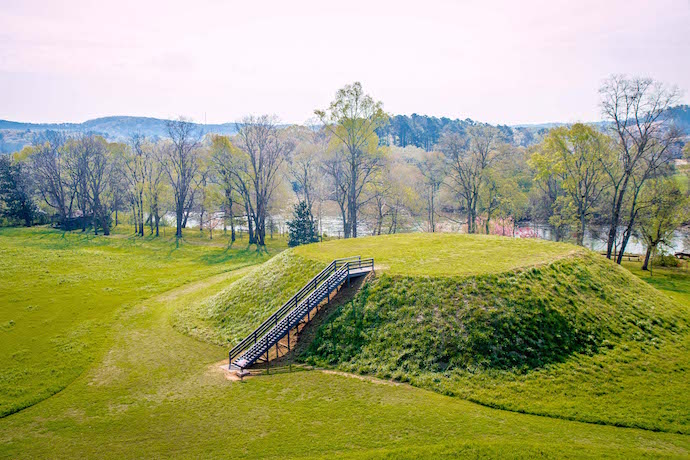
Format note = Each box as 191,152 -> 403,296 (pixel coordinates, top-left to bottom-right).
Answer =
0,116 -> 237,153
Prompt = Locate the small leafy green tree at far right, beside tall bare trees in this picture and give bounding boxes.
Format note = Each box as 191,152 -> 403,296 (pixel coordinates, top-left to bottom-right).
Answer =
638,177 -> 688,270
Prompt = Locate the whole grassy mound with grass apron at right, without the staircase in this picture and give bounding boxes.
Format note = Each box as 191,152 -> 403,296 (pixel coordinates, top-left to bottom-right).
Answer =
180,234 -> 690,433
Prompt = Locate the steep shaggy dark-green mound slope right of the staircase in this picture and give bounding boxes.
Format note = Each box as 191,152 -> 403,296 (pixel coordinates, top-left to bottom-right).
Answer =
310,254 -> 682,377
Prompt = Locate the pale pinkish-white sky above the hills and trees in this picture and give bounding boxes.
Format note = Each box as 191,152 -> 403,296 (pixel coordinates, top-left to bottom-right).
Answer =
0,0 -> 690,124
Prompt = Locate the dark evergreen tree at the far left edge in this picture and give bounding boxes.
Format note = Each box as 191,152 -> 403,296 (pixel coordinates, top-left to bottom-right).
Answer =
0,155 -> 36,227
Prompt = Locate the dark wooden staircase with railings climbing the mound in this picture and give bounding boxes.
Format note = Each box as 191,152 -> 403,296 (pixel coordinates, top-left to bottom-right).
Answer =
228,256 -> 374,370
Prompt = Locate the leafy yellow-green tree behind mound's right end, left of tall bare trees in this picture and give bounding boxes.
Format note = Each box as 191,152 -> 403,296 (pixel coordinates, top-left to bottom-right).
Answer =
530,123 -> 611,246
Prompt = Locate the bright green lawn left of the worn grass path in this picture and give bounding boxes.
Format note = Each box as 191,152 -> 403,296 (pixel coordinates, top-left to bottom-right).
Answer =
0,227 -> 284,416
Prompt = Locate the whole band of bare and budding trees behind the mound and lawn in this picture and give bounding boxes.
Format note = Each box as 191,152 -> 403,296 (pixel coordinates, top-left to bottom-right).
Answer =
0,76 -> 690,268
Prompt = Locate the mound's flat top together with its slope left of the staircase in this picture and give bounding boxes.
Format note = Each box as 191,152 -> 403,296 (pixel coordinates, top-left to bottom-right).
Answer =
173,234 -> 578,346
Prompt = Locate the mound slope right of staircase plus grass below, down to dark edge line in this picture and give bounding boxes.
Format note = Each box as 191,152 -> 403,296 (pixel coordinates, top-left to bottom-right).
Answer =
303,246 -> 690,434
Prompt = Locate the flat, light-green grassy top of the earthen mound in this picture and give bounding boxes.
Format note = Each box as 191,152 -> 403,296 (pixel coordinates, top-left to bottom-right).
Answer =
295,233 -> 580,276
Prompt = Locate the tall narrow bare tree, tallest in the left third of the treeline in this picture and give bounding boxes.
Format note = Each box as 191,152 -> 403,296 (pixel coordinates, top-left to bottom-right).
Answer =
162,118 -> 200,238
